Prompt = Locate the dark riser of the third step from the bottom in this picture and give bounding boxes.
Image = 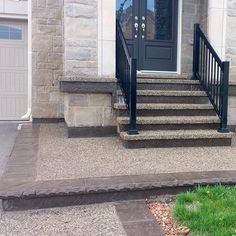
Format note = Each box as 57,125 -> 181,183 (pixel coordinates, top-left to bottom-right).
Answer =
117,109 -> 216,116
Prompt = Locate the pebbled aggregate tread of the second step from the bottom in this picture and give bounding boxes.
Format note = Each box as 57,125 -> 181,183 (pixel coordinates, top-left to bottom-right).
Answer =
117,116 -> 220,125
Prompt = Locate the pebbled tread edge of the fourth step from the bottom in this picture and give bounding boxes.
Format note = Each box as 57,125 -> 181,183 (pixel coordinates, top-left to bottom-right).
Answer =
117,90 -> 207,97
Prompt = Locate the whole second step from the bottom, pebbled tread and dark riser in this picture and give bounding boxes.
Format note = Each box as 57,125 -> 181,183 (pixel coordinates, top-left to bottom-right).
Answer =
117,116 -> 220,132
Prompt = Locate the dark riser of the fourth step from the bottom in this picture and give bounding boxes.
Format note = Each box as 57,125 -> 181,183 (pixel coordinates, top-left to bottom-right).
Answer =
137,96 -> 209,104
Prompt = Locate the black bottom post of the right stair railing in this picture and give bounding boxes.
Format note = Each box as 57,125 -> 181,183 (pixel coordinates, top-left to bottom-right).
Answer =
219,61 -> 229,133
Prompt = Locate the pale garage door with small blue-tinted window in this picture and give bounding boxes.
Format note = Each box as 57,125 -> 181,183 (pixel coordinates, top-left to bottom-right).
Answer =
0,20 -> 28,120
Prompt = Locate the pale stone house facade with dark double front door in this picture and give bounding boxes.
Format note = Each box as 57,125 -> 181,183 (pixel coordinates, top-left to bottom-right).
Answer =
0,0 -> 236,146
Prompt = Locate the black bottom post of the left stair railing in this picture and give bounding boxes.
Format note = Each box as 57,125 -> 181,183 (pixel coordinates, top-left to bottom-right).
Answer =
128,58 -> 138,135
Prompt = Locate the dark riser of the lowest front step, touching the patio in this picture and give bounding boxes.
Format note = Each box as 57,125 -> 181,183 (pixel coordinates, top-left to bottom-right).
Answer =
122,138 -> 231,149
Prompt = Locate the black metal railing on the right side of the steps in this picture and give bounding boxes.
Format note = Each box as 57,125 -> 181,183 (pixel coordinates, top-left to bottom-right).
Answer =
193,24 -> 229,133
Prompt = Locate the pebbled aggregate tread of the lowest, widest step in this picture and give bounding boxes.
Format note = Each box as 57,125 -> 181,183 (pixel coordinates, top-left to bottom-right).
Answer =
120,130 -> 235,141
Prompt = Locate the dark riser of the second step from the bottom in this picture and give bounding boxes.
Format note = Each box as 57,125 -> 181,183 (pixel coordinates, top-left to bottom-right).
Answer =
118,124 -> 219,132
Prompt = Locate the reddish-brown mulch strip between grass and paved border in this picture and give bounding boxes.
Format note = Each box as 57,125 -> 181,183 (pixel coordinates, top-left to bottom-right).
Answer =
147,196 -> 190,236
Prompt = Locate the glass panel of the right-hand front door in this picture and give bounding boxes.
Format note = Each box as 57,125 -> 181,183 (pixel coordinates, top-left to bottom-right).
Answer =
146,0 -> 173,40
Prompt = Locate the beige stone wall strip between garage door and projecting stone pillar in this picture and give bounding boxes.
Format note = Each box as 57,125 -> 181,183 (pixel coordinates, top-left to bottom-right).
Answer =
32,0 -> 63,118
